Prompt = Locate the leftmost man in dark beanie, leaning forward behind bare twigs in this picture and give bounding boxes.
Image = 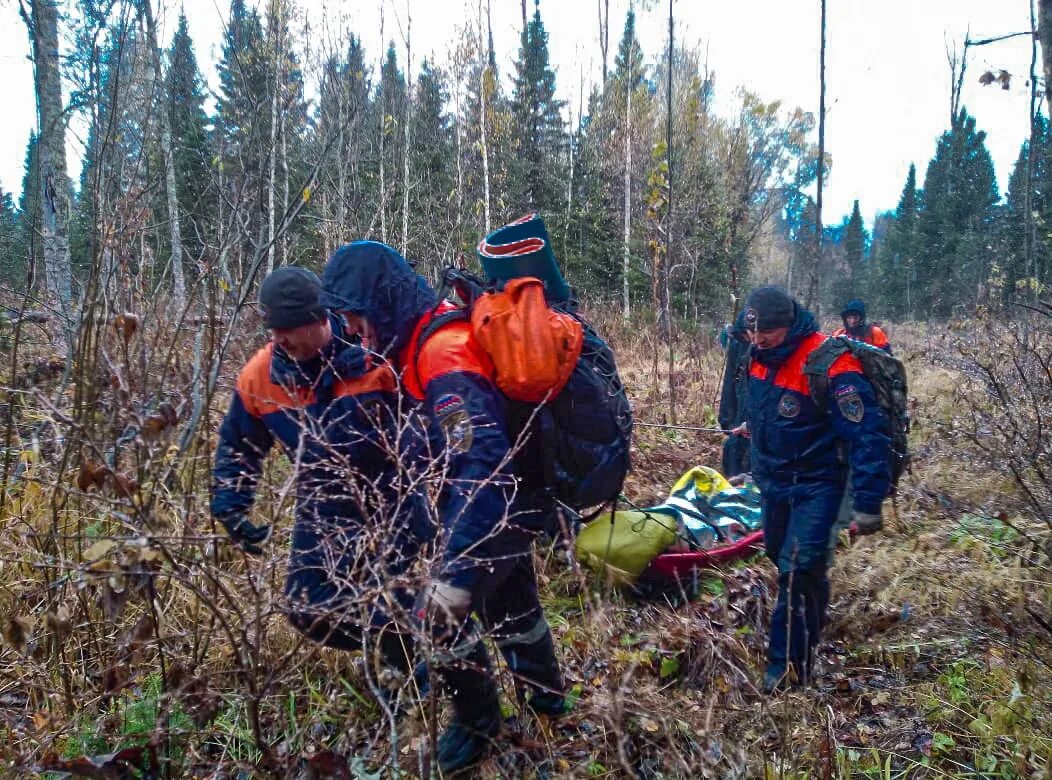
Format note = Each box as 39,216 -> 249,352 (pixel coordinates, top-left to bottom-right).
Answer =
211,267 -> 428,671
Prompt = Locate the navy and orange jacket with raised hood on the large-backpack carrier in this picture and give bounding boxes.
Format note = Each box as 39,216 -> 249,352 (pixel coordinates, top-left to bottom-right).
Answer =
323,241 -> 541,587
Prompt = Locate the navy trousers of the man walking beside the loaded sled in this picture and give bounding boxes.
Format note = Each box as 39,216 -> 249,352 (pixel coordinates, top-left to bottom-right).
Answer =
763,482 -> 844,680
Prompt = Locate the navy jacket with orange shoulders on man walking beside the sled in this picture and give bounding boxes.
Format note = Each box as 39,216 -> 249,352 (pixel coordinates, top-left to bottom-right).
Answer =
747,307 -> 890,514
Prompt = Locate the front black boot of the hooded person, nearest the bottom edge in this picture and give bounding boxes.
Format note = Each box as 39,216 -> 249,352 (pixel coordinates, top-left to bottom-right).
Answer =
436,642 -> 501,775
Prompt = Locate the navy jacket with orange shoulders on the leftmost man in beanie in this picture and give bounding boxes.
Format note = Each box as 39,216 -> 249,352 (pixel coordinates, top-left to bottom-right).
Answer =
211,317 -> 426,547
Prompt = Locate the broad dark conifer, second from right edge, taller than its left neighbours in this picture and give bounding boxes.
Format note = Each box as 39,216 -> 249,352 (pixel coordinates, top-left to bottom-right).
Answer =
916,109 -> 999,317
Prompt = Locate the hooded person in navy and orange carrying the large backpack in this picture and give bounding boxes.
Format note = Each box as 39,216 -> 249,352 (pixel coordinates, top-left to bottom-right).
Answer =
323,241 -> 563,773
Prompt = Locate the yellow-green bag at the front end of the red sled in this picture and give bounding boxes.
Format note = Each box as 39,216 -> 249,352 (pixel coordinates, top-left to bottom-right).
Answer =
576,508 -> 679,585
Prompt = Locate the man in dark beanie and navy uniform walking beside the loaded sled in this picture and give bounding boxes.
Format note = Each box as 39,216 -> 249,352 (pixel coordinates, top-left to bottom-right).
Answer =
742,287 -> 891,693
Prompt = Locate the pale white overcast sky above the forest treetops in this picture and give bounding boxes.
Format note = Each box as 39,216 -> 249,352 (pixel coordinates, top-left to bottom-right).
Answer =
0,0 -> 1031,222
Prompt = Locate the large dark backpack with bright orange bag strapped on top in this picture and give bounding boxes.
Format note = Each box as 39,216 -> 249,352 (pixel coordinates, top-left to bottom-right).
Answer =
416,268 -> 632,509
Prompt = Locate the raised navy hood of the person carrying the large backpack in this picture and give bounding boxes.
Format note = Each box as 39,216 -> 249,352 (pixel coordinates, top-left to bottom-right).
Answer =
322,241 -> 438,355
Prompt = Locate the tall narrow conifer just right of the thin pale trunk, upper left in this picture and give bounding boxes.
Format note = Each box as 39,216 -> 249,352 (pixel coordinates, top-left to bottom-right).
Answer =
165,13 -> 217,266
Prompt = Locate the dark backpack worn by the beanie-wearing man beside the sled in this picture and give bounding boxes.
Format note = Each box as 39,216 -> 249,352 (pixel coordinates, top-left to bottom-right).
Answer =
804,336 -> 910,489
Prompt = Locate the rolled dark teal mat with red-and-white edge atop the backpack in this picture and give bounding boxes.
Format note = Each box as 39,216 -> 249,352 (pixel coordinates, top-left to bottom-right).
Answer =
478,214 -> 571,302
